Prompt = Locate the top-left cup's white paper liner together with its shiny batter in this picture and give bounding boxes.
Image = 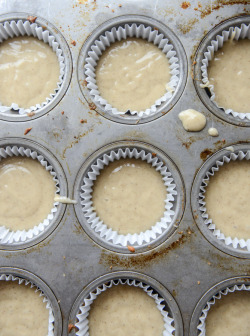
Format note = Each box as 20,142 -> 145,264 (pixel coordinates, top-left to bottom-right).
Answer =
0,15 -> 69,117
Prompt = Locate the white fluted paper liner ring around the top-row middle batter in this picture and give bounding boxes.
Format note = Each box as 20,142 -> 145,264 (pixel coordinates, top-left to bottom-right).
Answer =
85,23 -> 180,118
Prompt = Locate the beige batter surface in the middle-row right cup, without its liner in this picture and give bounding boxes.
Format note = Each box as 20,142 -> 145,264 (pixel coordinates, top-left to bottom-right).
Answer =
205,160 -> 250,239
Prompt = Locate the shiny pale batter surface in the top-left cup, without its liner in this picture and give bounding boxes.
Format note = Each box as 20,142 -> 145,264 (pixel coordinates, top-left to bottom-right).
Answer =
0,36 -> 60,108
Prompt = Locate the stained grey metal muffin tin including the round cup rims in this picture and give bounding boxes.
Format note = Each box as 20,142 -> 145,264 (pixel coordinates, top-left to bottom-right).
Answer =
0,0 -> 250,336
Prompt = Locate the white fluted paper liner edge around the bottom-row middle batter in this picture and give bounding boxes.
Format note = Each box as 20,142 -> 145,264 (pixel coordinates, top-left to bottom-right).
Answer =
75,279 -> 175,336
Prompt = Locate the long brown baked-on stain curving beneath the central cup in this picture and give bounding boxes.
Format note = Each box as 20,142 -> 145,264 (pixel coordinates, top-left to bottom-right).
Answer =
99,228 -> 193,268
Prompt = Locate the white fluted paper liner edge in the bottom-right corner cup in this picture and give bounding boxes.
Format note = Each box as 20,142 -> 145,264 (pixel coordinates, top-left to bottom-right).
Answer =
197,284 -> 250,336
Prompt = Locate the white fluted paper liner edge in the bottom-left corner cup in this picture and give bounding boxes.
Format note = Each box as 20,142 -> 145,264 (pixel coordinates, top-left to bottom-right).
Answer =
0,274 -> 55,336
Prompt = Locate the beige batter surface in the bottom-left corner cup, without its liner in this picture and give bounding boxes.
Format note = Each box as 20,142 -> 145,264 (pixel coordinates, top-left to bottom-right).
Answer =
0,281 -> 49,336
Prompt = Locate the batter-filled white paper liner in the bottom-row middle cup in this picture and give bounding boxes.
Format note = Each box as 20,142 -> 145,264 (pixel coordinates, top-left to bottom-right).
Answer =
75,279 -> 175,336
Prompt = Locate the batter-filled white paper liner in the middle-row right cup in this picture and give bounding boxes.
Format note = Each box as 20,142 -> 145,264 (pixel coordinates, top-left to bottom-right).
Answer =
199,150 -> 250,251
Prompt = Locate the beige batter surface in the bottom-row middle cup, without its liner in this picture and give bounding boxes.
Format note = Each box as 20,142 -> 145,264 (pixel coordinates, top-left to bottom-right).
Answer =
89,285 -> 164,336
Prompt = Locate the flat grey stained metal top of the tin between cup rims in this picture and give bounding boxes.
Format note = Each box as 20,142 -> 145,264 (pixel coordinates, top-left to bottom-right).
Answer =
0,0 -> 250,336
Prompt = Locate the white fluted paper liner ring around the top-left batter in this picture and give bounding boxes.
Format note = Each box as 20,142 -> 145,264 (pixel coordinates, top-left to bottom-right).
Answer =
0,20 -> 65,115
